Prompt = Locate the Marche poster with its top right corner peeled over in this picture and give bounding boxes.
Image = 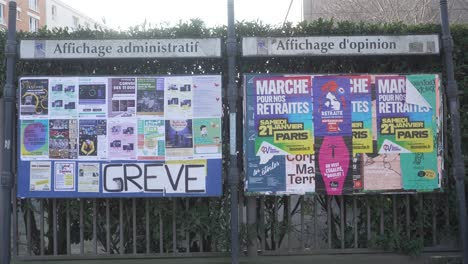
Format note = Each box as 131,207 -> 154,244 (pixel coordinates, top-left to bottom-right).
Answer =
375,76 -> 435,153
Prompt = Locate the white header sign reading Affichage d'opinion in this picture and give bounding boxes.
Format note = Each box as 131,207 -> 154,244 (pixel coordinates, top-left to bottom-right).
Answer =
242,35 -> 439,56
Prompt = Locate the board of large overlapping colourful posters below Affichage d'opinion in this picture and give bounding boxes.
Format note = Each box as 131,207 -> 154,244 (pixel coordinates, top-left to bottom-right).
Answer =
244,74 -> 444,195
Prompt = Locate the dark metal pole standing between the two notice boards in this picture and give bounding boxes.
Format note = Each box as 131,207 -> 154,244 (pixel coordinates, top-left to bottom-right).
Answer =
226,0 -> 239,264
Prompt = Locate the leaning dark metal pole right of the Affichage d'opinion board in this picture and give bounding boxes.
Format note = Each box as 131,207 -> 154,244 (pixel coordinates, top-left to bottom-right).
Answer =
440,0 -> 468,264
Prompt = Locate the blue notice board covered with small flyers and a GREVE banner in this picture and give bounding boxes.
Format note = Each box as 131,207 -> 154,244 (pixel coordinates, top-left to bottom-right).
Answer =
17,75 -> 222,197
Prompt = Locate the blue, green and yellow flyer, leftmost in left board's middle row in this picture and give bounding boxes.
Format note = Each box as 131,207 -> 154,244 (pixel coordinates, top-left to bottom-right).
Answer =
20,120 -> 49,160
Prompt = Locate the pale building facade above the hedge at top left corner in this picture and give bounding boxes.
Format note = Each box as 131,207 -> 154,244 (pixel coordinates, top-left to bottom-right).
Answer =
0,0 -> 105,32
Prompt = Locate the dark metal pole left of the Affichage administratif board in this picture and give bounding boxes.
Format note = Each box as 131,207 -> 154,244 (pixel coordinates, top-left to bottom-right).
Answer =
0,1 -> 16,264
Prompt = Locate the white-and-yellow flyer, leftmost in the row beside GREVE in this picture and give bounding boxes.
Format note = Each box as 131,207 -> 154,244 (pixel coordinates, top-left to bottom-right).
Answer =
29,161 -> 52,191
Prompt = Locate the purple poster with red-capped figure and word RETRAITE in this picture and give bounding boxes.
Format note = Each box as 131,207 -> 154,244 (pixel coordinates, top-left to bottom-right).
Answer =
312,76 -> 352,136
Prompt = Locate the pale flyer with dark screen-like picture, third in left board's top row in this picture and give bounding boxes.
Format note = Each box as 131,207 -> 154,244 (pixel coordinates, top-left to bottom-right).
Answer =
78,77 -> 107,118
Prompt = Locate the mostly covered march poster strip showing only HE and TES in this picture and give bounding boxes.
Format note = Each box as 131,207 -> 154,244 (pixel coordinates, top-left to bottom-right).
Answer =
350,75 -> 374,154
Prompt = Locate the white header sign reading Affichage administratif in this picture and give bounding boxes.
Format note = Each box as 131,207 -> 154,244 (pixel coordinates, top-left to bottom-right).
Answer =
20,38 -> 221,59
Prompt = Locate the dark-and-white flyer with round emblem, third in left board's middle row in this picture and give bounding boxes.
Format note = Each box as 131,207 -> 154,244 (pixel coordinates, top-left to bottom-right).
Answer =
78,119 -> 107,160
